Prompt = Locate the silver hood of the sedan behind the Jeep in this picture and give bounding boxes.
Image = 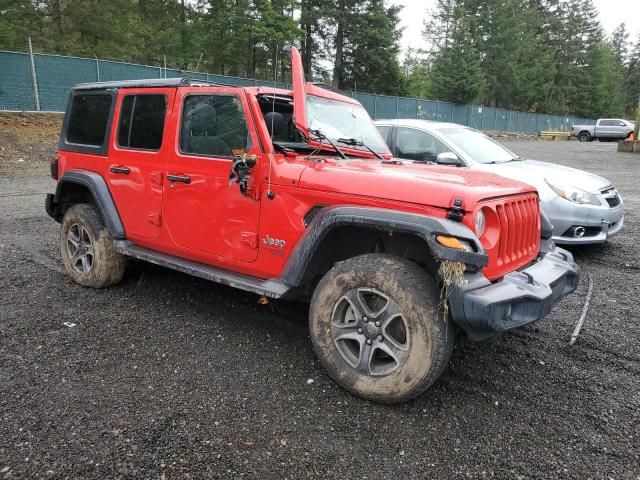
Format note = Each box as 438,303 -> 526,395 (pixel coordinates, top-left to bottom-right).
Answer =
474,160 -> 611,199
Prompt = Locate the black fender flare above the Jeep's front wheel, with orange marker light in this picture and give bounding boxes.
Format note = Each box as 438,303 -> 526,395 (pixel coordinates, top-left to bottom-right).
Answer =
281,206 -> 489,287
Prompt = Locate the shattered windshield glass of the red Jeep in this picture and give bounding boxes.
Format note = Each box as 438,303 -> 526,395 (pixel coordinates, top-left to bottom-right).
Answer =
307,95 -> 389,153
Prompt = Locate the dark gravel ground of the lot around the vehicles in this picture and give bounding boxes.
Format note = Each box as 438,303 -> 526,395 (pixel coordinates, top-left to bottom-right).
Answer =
0,125 -> 640,480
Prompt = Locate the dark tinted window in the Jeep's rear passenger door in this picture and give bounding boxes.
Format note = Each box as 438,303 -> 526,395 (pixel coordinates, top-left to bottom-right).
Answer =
118,95 -> 167,150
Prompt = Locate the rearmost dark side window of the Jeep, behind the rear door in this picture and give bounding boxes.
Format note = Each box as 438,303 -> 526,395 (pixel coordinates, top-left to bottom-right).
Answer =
66,94 -> 112,147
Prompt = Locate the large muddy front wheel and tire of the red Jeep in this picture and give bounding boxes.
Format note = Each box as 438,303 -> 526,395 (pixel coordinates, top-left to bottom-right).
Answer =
309,254 -> 455,403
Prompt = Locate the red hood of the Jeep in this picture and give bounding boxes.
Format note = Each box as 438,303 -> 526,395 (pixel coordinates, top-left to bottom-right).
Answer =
300,159 -> 535,210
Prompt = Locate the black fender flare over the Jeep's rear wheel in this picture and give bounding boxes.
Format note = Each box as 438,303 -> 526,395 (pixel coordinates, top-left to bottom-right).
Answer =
47,170 -> 126,240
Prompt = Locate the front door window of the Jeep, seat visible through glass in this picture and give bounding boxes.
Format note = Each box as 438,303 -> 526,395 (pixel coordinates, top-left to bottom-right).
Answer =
180,95 -> 251,157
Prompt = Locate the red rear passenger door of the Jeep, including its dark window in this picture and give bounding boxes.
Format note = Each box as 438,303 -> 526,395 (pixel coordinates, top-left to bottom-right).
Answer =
107,88 -> 175,239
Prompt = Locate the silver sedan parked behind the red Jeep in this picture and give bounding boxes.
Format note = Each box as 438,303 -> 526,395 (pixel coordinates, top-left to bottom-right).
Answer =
376,119 -> 624,244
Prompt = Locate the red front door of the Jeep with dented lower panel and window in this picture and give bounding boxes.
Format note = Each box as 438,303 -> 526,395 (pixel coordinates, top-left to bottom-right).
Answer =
163,87 -> 260,262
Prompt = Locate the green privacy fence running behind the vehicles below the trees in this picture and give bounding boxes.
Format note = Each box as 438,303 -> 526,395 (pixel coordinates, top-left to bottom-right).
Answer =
0,51 -> 595,133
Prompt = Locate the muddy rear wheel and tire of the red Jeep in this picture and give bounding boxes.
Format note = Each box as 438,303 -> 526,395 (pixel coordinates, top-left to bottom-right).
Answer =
60,203 -> 126,288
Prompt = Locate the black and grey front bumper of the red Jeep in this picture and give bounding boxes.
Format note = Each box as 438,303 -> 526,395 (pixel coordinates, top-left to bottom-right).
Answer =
449,241 -> 580,342
